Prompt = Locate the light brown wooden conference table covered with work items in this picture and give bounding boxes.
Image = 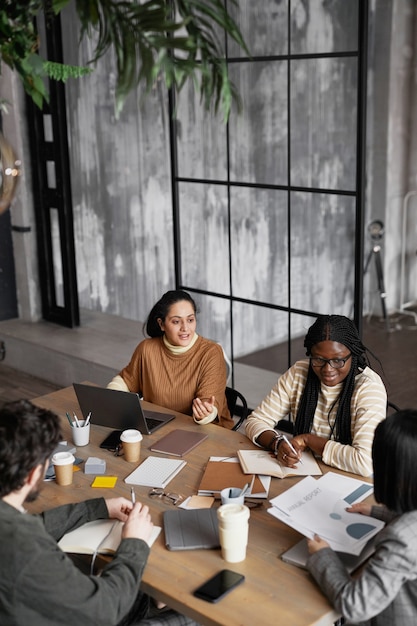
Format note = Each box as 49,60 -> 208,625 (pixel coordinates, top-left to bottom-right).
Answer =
28,387 -> 360,626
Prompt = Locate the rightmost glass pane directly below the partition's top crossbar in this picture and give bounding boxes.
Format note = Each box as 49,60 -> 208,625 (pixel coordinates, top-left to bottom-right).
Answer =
291,59 -> 357,191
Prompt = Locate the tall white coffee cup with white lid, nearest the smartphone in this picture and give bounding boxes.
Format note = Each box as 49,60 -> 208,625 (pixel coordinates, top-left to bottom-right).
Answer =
217,504 -> 250,563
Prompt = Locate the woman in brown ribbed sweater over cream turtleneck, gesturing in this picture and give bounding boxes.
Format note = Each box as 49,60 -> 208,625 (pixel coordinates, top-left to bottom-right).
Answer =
107,290 -> 234,428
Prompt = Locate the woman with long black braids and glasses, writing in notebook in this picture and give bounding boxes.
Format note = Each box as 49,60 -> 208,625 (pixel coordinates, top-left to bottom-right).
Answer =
246,315 -> 387,476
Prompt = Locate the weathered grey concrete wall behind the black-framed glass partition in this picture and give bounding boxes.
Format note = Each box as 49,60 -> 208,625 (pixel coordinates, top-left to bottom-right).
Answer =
0,0 -> 417,352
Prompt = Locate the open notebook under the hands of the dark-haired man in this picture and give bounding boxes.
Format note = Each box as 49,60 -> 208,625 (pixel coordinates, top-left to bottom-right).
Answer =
58,519 -> 161,554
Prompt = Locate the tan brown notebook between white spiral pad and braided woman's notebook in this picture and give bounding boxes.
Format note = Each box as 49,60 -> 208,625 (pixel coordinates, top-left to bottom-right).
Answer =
198,461 -> 268,498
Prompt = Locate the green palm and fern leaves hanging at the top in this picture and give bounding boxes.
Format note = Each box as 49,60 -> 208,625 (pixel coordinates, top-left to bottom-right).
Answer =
0,0 -> 249,119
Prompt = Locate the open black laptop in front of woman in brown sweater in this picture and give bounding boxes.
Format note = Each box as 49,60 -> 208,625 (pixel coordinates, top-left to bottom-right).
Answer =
73,383 -> 175,435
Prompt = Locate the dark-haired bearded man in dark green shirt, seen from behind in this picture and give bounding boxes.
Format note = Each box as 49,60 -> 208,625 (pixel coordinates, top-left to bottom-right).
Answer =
0,400 -> 192,626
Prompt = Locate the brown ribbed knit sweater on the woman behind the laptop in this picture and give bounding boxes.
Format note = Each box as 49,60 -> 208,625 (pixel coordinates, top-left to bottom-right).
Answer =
109,336 -> 234,428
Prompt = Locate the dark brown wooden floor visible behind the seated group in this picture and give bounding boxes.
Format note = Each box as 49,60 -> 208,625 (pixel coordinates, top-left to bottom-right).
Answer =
0,315 -> 417,408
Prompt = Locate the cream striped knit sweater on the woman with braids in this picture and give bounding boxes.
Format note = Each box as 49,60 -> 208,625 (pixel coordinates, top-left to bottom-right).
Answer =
246,359 -> 387,476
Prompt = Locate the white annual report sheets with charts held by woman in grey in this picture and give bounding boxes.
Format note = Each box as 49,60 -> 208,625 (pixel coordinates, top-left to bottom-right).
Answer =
268,472 -> 384,554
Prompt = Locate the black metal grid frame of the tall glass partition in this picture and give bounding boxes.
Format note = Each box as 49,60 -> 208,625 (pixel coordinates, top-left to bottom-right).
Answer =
169,0 -> 368,366
